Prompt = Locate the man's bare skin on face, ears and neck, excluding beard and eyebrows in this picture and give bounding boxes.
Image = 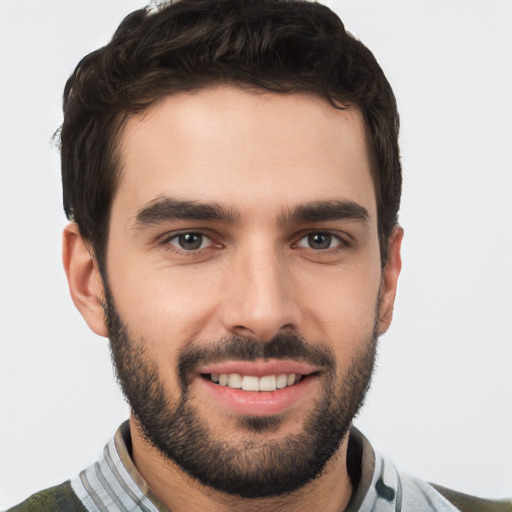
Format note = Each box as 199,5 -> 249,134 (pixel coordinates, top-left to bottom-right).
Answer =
63,86 -> 403,512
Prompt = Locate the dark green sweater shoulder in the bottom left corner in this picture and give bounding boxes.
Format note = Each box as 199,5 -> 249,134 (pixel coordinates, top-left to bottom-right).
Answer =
6,480 -> 86,512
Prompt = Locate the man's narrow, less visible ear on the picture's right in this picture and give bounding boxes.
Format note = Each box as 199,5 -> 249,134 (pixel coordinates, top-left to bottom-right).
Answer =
378,226 -> 404,335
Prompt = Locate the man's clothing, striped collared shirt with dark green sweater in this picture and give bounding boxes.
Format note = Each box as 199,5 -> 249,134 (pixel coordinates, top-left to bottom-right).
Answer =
8,422 -> 512,512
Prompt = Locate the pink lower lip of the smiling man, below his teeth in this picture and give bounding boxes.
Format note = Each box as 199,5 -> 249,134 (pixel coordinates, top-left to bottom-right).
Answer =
199,375 -> 316,416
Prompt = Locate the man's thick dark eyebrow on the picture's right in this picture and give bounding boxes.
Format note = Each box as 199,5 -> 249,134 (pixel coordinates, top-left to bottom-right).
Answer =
279,201 -> 370,224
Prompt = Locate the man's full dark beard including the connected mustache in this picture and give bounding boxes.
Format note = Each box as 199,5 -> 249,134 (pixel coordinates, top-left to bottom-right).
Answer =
103,278 -> 378,498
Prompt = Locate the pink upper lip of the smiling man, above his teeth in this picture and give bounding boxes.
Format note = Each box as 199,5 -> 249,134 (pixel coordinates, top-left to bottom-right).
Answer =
197,359 -> 320,377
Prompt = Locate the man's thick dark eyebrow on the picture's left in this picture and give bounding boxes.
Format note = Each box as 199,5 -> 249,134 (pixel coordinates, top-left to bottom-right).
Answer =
133,197 -> 238,228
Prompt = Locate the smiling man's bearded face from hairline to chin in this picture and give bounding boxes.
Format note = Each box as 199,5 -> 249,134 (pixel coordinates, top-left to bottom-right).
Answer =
99,86 -> 394,497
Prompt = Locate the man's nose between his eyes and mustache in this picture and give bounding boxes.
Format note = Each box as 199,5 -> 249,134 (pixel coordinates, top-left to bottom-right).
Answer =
221,244 -> 300,342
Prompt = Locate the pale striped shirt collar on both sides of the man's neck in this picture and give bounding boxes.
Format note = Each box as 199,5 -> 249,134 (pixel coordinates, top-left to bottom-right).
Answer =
71,422 -> 457,512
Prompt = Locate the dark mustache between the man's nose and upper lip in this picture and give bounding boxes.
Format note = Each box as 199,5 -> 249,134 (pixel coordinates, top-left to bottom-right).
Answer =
177,333 -> 335,383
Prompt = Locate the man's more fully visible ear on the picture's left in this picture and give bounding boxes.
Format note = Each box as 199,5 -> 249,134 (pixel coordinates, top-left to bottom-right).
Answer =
62,222 -> 108,337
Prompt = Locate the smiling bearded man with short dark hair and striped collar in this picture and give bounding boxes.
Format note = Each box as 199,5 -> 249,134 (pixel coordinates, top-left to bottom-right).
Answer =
7,0 -> 510,511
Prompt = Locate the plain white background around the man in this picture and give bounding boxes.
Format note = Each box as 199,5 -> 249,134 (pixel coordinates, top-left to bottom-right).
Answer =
0,0 -> 512,508
